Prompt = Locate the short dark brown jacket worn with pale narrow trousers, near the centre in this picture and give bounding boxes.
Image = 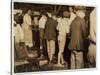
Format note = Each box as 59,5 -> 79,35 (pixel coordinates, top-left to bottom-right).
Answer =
45,18 -> 58,40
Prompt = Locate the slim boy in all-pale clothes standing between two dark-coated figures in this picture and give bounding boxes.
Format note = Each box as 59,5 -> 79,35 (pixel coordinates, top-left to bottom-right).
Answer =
57,11 -> 69,67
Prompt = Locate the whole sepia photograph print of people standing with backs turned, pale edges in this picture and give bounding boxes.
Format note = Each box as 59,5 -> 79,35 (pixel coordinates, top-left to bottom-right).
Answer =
11,2 -> 96,73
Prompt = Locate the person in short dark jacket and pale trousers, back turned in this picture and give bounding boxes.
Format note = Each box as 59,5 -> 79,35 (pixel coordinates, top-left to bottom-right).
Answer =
45,13 -> 57,63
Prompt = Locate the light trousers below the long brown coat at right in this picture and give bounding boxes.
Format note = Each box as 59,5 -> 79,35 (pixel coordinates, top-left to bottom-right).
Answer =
71,50 -> 84,69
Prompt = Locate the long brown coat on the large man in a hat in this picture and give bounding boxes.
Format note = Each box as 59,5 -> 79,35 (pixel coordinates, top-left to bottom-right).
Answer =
69,16 -> 86,50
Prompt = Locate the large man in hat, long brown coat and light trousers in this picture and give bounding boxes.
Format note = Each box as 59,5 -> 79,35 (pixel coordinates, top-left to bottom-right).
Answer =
69,6 -> 86,69
